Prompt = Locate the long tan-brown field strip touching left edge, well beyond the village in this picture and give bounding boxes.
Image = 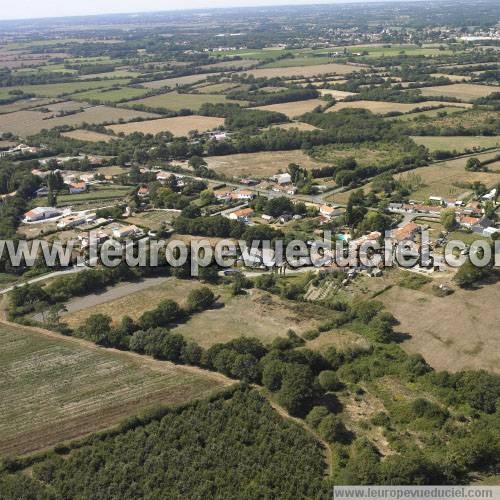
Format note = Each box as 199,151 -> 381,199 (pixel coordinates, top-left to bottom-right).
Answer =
0,106 -> 158,137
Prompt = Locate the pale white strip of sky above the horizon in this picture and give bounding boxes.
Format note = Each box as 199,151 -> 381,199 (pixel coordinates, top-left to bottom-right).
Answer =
0,0 -> 368,20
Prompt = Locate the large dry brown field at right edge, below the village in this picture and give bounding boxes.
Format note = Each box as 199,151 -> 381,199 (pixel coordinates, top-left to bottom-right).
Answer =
377,283 -> 500,373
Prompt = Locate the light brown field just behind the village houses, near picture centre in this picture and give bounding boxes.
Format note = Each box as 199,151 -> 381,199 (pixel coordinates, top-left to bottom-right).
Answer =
205,151 -> 325,178
